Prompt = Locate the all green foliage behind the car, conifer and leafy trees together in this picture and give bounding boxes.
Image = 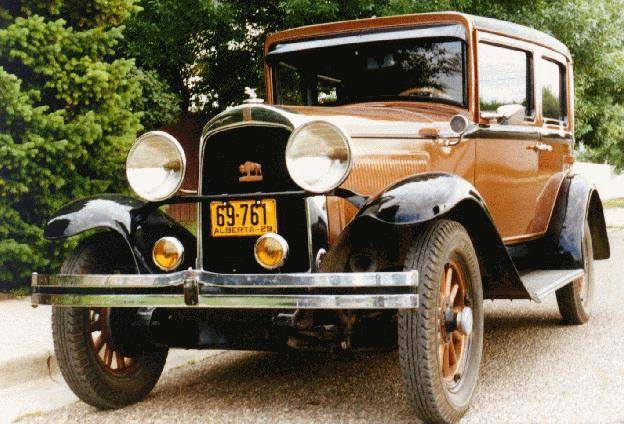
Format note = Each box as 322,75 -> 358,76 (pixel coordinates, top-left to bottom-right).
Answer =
0,0 -> 624,288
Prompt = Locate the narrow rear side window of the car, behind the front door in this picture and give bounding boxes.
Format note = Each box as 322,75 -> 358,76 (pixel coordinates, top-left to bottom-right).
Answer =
540,59 -> 567,123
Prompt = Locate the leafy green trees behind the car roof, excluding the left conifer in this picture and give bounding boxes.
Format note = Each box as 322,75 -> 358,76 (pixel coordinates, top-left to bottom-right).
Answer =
128,0 -> 624,168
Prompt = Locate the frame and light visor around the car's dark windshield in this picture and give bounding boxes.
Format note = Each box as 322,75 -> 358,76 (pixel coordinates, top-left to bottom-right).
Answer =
265,23 -> 471,109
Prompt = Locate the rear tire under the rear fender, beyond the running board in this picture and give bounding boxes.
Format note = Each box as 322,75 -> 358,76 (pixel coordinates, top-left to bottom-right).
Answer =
556,222 -> 594,325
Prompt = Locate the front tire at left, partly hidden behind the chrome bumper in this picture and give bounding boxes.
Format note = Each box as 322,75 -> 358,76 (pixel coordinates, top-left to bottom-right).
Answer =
52,233 -> 167,409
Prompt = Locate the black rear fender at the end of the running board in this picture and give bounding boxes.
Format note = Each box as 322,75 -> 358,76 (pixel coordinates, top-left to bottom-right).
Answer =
526,175 -> 611,269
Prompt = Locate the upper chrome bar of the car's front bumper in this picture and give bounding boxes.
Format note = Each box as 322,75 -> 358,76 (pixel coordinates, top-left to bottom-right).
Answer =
32,270 -> 418,289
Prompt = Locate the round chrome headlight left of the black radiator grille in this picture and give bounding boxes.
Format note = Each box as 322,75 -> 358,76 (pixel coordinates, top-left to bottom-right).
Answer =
126,131 -> 186,202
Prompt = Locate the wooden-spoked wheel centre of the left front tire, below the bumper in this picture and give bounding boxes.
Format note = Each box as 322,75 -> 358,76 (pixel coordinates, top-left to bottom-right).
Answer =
89,308 -> 134,376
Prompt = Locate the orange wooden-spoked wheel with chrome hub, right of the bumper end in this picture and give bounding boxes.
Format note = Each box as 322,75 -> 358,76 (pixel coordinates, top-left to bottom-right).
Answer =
438,260 -> 473,385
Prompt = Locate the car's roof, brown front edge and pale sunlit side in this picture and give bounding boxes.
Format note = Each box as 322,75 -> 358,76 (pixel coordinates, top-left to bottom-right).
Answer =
265,12 -> 570,57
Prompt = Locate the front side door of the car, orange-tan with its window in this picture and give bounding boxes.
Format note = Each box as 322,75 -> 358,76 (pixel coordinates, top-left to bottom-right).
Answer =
475,40 -> 544,243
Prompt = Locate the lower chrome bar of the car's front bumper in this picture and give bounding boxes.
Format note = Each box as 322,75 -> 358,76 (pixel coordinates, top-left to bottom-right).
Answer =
32,293 -> 418,309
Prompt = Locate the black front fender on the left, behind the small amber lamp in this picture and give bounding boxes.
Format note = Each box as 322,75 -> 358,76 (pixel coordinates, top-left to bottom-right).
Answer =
43,194 -> 197,273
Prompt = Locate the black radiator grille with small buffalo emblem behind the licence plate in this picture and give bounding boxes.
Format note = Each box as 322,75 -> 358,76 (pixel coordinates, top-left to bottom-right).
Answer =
201,126 -> 310,274
